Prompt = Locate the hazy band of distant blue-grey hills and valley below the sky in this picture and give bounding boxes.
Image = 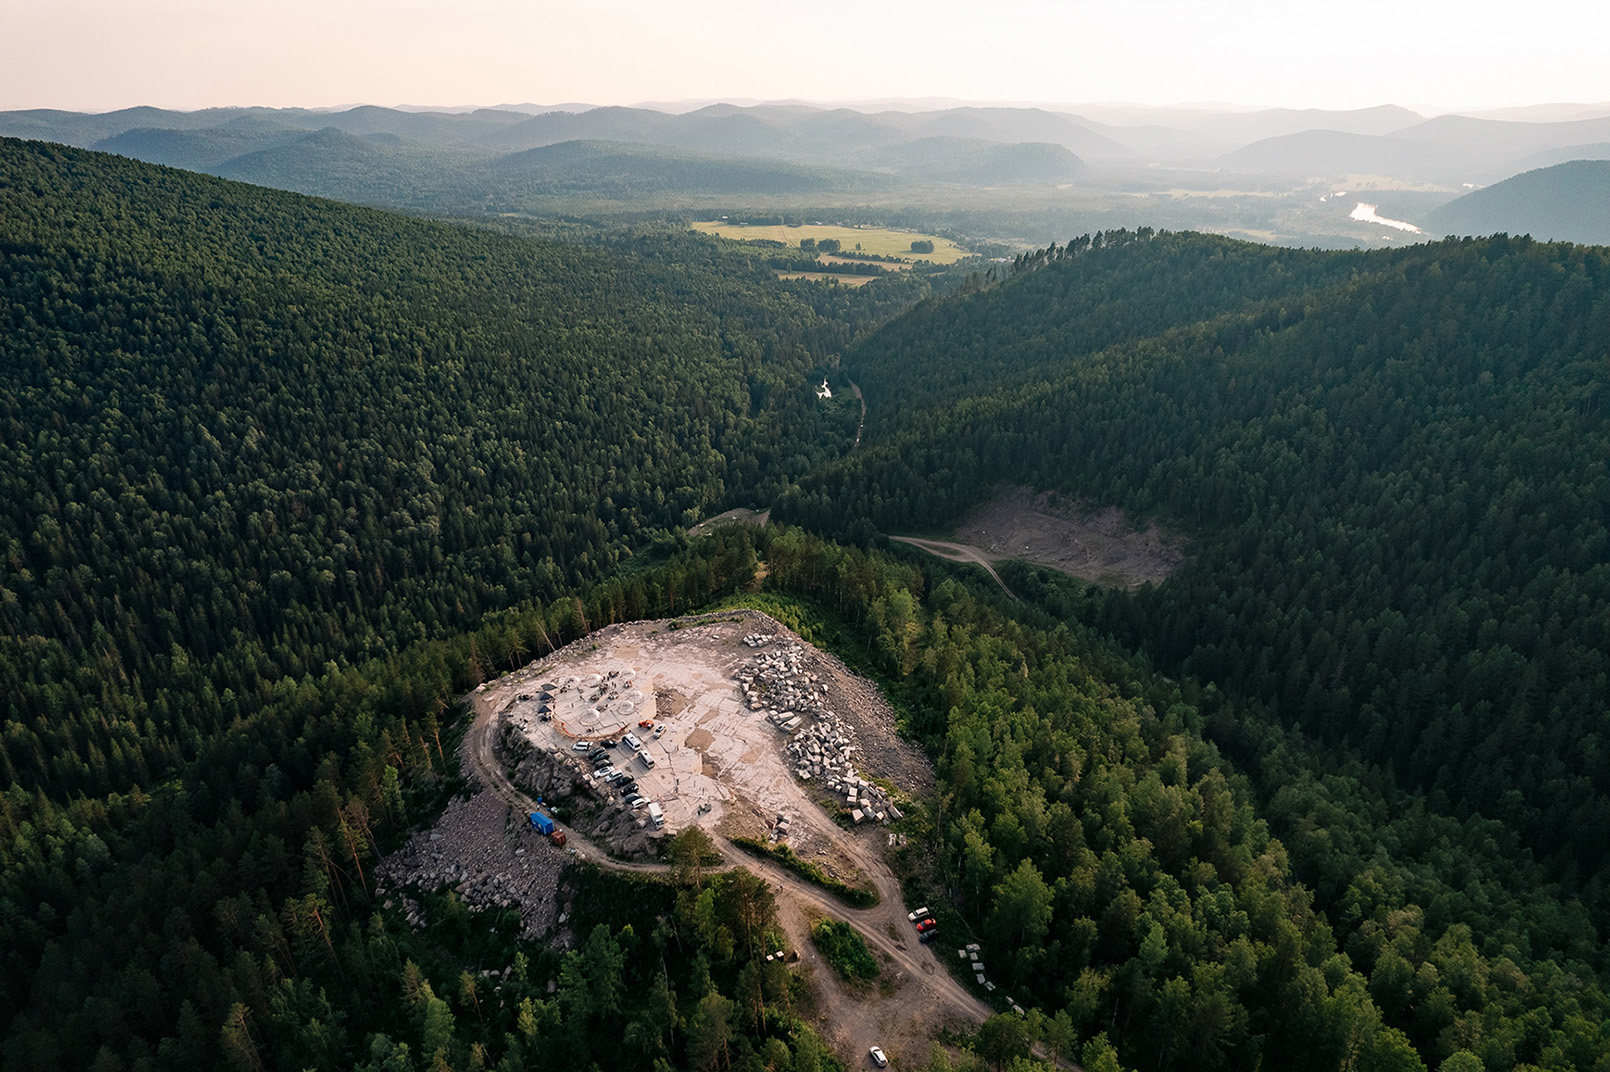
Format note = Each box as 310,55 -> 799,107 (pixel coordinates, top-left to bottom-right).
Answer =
12,101 -> 1610,246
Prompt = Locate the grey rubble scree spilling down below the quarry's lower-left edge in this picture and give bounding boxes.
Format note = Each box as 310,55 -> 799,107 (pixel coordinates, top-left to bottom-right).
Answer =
375,792 -> 570,940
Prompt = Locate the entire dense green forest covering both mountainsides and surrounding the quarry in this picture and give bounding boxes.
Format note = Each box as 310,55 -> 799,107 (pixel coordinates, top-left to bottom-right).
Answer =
0,142 -> 1610,1072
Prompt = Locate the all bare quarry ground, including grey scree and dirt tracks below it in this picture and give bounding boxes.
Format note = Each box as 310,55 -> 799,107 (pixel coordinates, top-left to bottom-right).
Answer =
382,610 -> 992,1069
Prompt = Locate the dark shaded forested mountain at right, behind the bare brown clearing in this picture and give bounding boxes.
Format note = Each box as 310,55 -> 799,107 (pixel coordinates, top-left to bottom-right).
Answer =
779,235 -> 1610,930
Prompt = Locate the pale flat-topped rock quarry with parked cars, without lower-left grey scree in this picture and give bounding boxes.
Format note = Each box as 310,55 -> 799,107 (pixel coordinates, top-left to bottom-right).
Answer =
477,610 -> 932,866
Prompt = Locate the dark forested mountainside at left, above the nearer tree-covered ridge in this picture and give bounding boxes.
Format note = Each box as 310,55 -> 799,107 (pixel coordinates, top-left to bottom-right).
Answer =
0,131 -> 908,800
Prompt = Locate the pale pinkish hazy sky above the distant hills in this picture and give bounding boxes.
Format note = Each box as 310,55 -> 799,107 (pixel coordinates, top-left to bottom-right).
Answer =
0,0 -> 1610,111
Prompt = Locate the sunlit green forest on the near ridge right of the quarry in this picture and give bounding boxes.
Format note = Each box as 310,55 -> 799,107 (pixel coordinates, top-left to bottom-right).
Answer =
765,531 -> 1610,1069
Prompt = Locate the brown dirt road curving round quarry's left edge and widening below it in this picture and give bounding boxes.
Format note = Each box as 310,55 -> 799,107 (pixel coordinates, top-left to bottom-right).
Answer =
464,679 -> 993,1061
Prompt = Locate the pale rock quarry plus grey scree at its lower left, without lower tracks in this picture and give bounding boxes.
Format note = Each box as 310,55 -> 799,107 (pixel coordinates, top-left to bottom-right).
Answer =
378,610 -> 934,942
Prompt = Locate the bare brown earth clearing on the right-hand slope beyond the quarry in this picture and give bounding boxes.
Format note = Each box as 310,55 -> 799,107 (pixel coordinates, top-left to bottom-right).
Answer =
897,488 -> 1185,591
